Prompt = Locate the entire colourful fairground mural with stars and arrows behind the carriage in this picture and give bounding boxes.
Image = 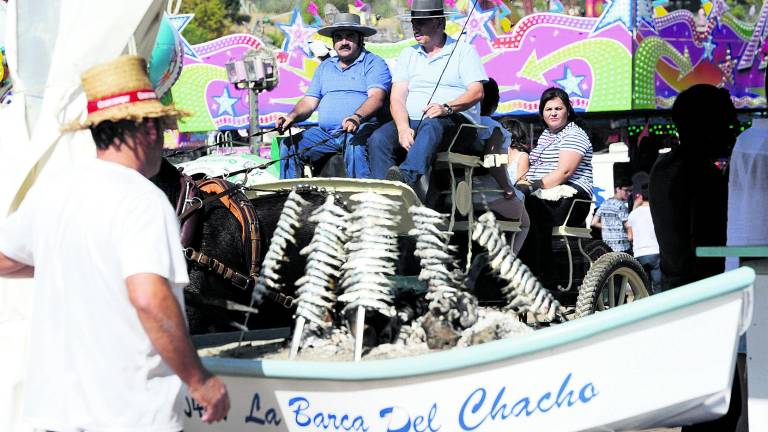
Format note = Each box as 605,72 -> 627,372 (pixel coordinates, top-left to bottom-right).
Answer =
170,0 -> 768,132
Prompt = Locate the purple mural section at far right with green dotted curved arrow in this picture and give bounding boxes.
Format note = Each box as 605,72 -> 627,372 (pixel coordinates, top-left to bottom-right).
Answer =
634,0 -> 768,109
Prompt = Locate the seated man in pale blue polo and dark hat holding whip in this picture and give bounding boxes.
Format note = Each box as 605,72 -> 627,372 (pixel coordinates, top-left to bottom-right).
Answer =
368,0 -> 488,190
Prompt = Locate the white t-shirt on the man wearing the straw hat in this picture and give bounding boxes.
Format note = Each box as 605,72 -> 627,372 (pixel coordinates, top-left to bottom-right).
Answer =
0,159 -> 188,432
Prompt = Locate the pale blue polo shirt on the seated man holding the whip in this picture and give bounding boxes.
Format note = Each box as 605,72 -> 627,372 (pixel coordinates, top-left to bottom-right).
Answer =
393,36 -> 488,123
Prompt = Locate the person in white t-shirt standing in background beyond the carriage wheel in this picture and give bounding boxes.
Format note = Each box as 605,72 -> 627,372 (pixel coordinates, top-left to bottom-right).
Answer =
627,172 -> 661,294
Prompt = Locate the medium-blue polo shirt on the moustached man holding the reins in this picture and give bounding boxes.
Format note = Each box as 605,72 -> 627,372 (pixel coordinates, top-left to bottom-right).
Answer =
306,50 -> 392,131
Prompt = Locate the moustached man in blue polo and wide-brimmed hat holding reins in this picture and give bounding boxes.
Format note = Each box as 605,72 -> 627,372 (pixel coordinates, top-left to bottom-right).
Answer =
276,13 -> 392,178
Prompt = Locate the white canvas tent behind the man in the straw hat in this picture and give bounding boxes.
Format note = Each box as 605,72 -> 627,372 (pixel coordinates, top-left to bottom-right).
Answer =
0,0 -> 167,431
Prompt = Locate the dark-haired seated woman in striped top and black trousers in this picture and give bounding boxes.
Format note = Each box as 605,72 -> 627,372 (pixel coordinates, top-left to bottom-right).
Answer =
518,87 -> 592,278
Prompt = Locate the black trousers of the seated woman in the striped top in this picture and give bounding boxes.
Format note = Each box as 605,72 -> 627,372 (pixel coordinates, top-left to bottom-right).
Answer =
518,184 -> 591,280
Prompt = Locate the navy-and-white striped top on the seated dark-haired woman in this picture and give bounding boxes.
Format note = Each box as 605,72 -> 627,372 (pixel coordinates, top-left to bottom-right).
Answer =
528,122 -> 592,196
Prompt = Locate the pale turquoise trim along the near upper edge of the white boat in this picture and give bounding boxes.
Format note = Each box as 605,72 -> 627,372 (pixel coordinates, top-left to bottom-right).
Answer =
203,267 -> 755,381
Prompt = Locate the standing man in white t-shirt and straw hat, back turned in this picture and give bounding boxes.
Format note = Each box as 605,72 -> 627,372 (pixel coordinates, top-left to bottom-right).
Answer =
0,56 -> 229,432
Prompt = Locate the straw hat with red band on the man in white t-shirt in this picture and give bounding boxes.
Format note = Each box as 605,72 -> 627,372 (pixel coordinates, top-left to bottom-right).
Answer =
62,55 -> 189,131
